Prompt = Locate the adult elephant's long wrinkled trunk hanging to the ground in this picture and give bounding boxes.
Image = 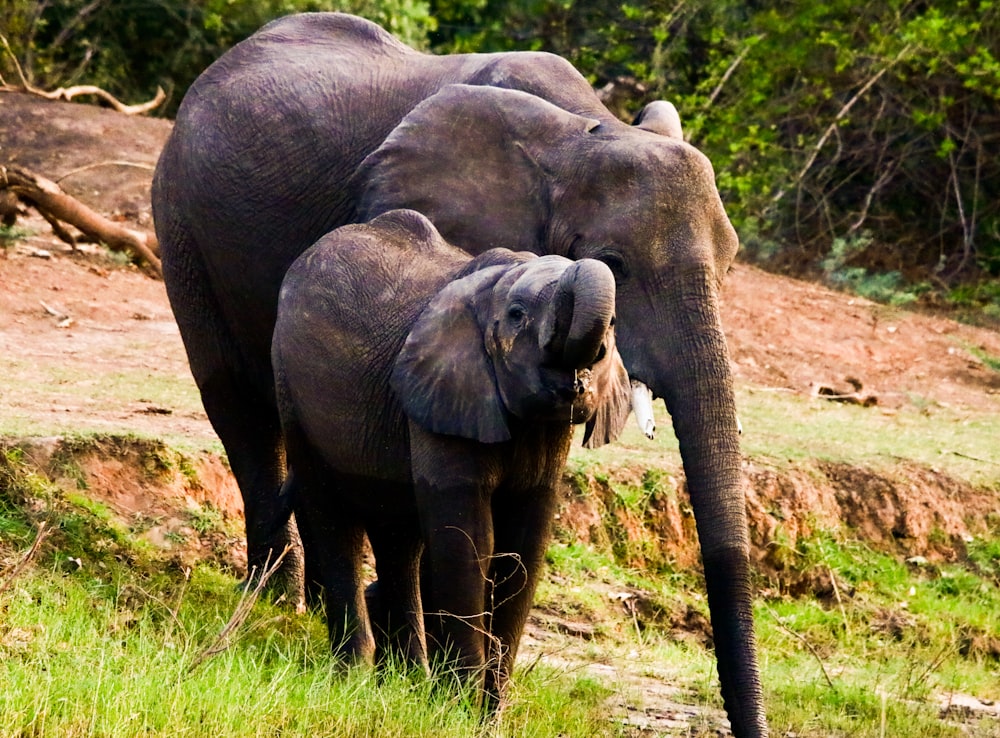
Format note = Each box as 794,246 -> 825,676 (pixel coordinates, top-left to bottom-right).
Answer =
654,274 -> 767,738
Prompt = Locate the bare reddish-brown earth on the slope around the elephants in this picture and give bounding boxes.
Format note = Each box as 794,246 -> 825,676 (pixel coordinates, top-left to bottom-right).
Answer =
0,94 -> 1000,735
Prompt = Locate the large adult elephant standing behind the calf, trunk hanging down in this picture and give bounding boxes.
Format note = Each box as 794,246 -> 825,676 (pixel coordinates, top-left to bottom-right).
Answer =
153,14 -> 767,738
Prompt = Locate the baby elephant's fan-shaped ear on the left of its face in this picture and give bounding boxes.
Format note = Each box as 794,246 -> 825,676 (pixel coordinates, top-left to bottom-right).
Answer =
389,258 -> 523,443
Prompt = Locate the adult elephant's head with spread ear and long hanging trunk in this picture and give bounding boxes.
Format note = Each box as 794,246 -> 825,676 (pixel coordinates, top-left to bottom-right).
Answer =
359,85 -> 767,736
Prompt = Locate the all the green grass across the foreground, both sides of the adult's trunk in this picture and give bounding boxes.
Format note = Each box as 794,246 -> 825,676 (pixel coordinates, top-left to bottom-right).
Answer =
0,451 -> 1000,738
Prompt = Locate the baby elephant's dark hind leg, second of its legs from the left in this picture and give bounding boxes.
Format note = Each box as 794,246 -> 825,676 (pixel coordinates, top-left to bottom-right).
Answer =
365,524 -> 427,671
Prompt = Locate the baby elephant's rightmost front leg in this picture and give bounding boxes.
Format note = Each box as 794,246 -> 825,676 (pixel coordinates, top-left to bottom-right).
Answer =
486,488 -> 556,709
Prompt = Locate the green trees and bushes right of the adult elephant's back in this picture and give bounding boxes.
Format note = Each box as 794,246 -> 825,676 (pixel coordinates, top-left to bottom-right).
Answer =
432,0 -> 1000,285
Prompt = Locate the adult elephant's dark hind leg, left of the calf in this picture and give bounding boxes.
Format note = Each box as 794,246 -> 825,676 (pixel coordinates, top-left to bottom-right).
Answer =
163,233 -> 304,604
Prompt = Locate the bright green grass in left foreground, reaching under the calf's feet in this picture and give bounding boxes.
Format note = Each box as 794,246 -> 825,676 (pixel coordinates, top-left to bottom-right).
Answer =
0,449 -> 618,738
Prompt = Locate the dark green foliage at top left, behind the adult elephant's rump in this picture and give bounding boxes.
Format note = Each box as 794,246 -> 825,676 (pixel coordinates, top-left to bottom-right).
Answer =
0,0 -> 434,113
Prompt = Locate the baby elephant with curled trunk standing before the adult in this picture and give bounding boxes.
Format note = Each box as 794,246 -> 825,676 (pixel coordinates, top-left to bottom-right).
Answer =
272,210 -> 630,698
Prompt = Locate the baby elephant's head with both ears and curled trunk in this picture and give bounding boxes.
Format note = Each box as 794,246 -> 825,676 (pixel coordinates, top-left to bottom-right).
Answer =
391,249 -> 631,445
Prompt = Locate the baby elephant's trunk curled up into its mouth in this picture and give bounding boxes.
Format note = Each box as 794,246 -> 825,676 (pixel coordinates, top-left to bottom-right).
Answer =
543,259 -> 615,369
